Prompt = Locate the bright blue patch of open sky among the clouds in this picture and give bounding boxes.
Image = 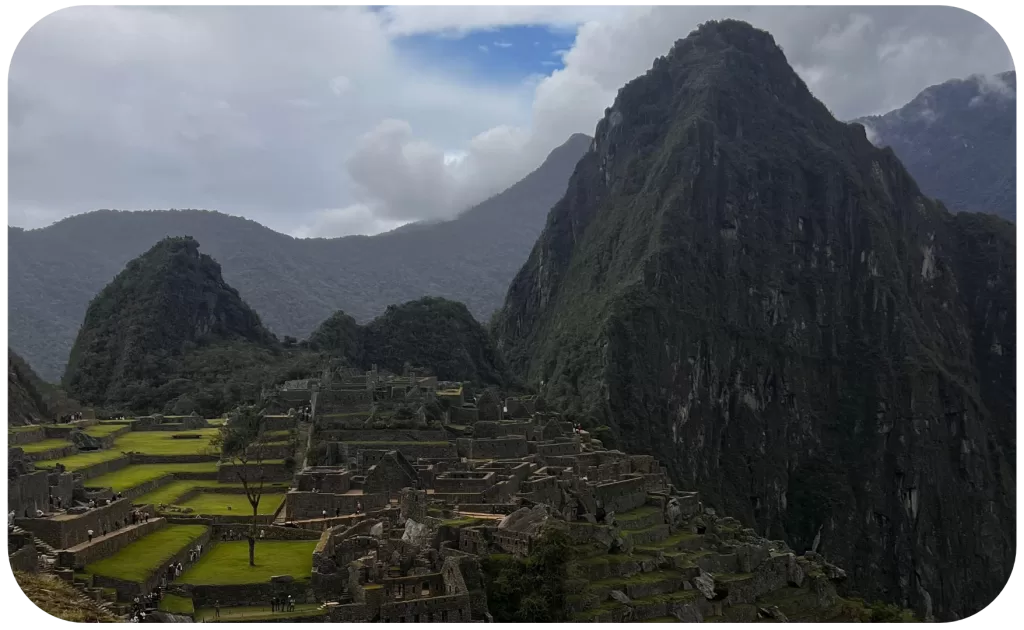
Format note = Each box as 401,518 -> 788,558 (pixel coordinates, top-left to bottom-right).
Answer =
395,27 -> 575,84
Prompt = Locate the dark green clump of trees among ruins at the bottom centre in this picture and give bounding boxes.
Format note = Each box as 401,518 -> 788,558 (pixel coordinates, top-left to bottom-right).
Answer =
483,528 -> 572,624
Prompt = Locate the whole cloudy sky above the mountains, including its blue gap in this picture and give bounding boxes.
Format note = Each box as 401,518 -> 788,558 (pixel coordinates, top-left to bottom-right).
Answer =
7,4 -> 1015,237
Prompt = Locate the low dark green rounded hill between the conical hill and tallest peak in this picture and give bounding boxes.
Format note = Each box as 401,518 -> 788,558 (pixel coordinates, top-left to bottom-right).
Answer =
309,297 -> 509,385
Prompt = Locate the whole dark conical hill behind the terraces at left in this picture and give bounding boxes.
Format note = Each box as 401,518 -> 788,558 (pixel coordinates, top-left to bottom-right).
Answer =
63,237 -> 317,413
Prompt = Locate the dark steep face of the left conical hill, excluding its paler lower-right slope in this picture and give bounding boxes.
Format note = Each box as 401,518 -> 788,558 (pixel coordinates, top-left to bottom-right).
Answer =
63,237 -> 274,404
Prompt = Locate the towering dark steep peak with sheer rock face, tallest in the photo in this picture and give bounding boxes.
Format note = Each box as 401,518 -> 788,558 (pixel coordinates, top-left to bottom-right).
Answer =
494,20 -> 1018,619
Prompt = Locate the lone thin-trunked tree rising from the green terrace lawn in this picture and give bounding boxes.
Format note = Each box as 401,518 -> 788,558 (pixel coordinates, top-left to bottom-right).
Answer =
211,406 -> 267,566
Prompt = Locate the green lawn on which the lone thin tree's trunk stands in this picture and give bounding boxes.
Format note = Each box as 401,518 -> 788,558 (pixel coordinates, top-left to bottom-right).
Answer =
179,540 -> 318,590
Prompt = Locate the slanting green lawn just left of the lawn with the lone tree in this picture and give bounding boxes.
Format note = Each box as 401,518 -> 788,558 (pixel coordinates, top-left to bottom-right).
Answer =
85,524 -> 209,582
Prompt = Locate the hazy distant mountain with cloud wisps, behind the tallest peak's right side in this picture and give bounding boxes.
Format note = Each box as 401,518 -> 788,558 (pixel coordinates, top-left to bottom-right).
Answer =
855,71 -> 1018,222
